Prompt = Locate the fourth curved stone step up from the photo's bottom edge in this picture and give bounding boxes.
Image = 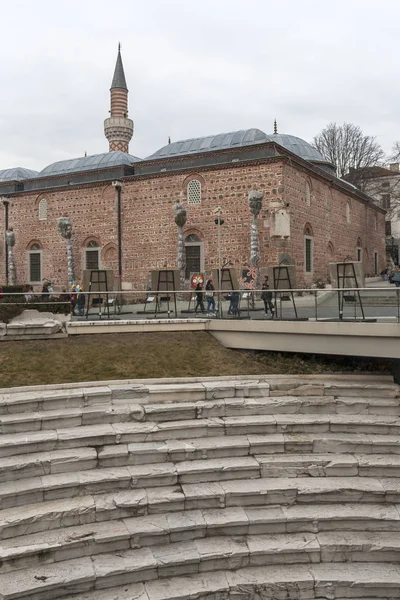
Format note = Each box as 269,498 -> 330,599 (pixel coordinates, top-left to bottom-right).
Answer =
0,477 -> 400,539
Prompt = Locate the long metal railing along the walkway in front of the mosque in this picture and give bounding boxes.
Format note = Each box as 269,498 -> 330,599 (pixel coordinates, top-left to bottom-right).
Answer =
0,287 -> 400,323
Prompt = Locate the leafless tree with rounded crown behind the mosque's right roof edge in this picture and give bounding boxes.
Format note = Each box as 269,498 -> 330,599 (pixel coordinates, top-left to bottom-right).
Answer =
313,123 -> 384,189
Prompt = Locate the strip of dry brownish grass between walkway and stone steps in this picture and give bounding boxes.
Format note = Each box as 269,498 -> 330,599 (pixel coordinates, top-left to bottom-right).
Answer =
0,332 -> 390,387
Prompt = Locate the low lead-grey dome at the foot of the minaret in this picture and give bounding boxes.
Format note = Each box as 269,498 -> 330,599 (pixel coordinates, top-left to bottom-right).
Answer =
39,151 -> 141,177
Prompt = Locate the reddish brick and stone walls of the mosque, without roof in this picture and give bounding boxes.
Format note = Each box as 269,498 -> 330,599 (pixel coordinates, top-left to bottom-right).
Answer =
0,159 -> 385,289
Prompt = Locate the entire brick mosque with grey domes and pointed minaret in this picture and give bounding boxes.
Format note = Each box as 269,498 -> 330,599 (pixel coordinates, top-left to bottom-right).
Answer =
0,49 -> 385,290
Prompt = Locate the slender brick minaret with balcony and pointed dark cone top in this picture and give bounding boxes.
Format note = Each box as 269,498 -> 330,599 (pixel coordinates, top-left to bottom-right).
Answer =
104,44 -> 133,152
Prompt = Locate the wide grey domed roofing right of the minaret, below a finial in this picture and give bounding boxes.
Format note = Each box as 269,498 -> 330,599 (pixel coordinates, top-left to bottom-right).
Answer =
147,129 -> 330,164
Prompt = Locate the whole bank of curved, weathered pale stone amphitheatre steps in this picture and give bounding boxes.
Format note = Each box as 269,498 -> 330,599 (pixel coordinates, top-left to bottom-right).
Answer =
0,376 -> 400,600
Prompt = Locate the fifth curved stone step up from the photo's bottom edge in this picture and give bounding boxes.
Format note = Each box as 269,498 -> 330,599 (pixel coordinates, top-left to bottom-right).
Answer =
0,448 -> 400,509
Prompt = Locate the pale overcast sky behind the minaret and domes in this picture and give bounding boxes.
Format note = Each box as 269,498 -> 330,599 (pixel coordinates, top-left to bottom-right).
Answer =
0,0 -> 400,170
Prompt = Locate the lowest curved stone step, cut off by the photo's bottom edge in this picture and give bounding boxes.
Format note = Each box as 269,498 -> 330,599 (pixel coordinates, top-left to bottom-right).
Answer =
73,563 -> 400,600
